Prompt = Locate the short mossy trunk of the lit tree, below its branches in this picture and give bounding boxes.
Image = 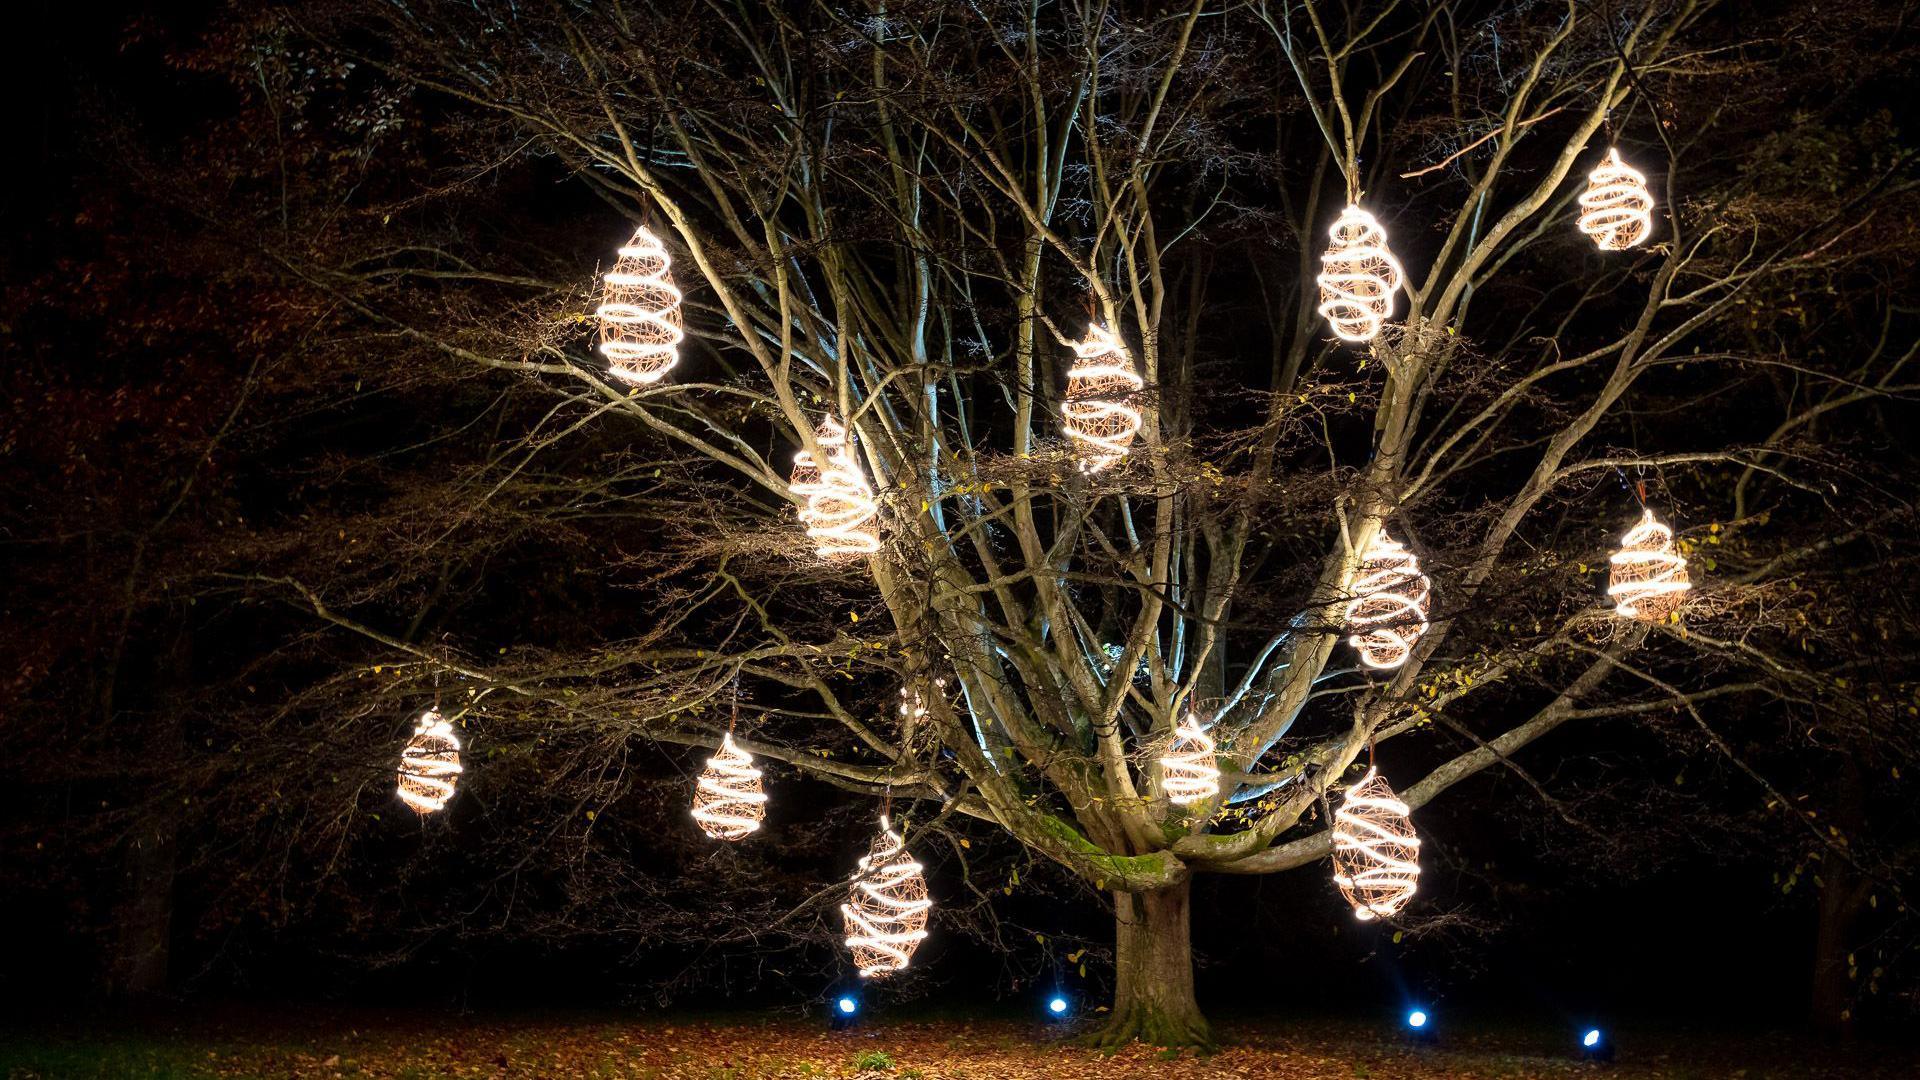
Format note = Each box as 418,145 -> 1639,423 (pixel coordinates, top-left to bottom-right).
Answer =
1092,880 -> 1213,1047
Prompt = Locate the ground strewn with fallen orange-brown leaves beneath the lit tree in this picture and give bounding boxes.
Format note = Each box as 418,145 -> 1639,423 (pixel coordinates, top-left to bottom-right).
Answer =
0,1009 -> 1920,1080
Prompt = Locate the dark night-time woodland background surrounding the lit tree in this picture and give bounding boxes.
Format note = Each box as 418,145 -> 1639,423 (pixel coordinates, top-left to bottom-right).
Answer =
0,2 -> 1920,1030
